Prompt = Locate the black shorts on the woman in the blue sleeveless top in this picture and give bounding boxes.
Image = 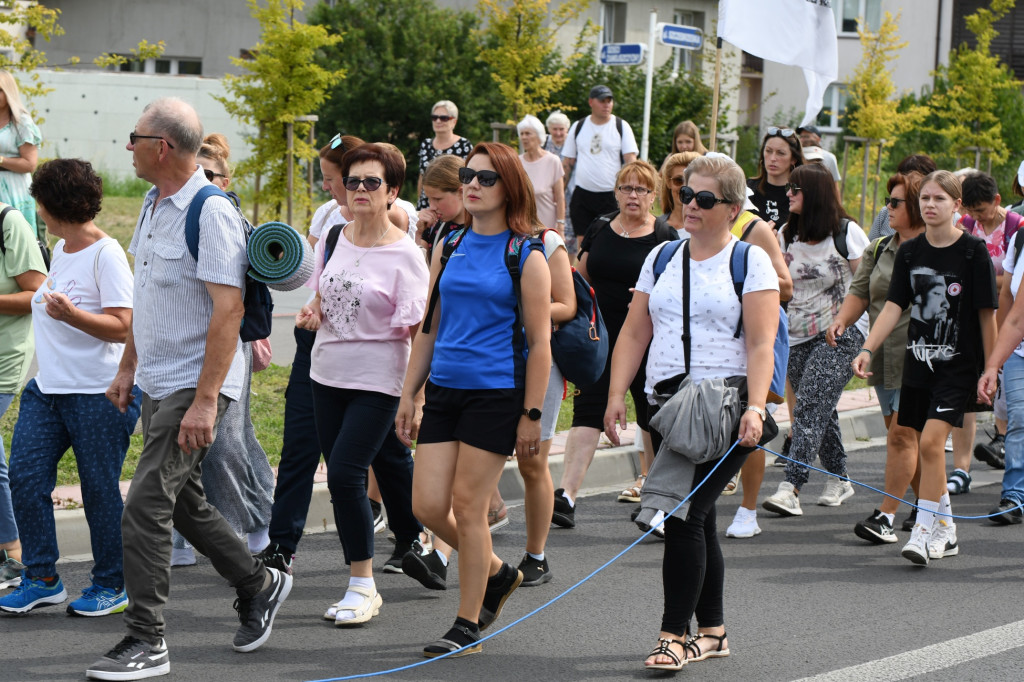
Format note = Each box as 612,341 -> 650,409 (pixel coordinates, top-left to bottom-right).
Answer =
417,380 -> 523,457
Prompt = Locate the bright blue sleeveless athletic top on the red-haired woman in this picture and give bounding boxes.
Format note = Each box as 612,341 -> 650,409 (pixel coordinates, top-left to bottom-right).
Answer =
430,229 -> 544,389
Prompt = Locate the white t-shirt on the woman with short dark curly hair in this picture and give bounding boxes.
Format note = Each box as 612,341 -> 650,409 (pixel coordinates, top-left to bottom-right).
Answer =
32,237 -> 134,394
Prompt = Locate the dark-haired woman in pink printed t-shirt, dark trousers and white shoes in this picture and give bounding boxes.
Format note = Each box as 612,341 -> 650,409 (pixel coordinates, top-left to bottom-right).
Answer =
296,144 -> 427,627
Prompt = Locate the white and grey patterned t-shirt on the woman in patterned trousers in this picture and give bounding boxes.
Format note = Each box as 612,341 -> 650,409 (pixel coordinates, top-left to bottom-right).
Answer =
778,220 -> 870,346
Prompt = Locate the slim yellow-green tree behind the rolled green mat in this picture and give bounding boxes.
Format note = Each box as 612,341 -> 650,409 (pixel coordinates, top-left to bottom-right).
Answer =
217,0 -> 344,220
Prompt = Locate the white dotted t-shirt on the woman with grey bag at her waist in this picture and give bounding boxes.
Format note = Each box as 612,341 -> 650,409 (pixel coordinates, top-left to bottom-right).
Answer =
636,237 -> 778,395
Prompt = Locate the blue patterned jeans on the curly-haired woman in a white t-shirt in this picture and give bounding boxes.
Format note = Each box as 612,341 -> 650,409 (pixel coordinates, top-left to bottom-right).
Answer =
10,379 -> 142,590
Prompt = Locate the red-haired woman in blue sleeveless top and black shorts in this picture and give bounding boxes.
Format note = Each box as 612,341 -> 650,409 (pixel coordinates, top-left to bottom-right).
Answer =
395,142 -> 551,657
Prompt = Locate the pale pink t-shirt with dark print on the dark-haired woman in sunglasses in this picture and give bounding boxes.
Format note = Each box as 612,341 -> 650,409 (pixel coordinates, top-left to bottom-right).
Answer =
309,229 -> 429,395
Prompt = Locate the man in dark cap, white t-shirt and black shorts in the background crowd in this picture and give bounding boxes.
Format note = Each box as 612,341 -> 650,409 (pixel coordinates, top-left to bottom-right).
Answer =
562,85 -> 640,245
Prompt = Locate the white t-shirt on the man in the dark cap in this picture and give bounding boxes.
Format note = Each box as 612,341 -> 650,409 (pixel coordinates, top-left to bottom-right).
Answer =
562,116 -> 639,191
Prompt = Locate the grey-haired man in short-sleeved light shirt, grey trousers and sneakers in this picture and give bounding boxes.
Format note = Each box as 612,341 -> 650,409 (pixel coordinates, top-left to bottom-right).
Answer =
86,98 -> 292,680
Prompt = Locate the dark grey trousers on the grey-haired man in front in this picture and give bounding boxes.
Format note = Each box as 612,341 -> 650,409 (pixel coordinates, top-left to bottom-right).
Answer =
121,389 -> 265,642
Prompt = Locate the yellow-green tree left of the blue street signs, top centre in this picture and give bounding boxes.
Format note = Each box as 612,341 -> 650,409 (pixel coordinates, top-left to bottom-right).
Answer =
477,0 -> 590,123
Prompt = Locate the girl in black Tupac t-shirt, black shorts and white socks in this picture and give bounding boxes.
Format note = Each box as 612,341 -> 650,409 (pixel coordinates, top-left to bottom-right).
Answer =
852,171 -> 997,566
